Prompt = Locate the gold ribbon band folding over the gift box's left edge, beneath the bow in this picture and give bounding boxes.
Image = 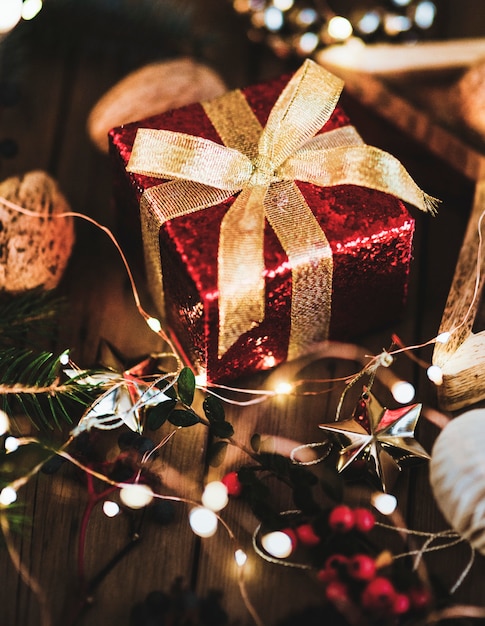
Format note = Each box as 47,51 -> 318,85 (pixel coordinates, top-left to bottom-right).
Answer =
140,181 -> 235,319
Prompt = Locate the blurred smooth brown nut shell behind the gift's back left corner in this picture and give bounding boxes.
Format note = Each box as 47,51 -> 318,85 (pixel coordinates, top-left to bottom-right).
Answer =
87,58 -> 227,152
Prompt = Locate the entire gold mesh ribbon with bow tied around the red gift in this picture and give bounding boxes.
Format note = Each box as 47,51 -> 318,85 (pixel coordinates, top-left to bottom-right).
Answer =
127,60 -> 433,359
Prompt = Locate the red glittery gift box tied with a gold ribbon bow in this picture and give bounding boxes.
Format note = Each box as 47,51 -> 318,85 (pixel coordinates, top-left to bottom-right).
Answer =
110,62 -> 424,382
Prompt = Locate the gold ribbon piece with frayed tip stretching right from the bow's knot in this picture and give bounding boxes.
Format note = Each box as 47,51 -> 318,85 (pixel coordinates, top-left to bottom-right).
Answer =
284,144 -> 439,215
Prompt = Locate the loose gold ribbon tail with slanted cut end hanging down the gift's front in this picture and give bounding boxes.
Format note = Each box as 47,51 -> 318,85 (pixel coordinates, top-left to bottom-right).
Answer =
218,187 -> 267,358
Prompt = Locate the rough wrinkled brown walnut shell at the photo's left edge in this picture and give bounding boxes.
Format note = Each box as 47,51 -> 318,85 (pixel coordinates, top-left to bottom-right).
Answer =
0,171 -> 75,293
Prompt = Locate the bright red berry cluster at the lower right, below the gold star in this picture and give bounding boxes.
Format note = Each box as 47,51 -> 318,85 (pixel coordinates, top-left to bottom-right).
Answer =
317,505 -> 431,619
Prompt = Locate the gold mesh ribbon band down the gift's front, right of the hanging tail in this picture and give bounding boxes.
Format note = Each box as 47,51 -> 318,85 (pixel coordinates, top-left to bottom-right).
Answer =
264,181 -> 333,360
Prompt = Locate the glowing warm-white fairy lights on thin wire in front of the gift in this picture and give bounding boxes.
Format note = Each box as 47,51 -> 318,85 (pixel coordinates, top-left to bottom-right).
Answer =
0,189 -> 485,625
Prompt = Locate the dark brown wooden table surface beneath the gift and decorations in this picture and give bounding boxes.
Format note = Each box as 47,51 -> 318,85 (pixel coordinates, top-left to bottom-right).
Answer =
0,0 -> 485,626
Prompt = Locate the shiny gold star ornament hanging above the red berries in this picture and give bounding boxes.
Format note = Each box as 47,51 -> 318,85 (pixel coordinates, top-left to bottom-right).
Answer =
319,391 -> 430,491
